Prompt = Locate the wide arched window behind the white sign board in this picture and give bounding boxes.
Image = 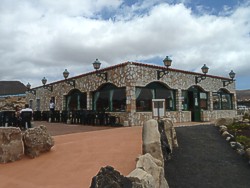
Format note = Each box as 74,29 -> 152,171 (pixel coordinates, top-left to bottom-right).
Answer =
135,82 -> 175,111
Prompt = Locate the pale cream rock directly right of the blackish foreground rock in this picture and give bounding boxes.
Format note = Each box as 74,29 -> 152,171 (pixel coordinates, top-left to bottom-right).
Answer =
136,153 -> 168,188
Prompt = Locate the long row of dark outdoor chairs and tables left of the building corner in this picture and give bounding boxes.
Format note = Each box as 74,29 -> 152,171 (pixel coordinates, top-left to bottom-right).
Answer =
0,110 -> 121,127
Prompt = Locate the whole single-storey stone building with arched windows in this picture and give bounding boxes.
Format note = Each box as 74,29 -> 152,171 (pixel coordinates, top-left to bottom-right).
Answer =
26,62 -> 236,126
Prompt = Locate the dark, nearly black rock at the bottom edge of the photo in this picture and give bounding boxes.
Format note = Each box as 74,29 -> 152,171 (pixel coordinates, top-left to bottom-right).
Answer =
90,166 -> 133,188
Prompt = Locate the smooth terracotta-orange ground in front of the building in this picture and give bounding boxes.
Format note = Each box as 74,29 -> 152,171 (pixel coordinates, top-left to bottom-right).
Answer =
0,125 -> 142,188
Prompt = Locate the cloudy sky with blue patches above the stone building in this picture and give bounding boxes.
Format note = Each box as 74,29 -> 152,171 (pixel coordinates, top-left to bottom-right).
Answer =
0,0 -> 250,90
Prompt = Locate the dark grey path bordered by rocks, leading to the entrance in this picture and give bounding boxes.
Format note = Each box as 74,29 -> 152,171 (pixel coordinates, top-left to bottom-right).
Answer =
166,125 -> 250,188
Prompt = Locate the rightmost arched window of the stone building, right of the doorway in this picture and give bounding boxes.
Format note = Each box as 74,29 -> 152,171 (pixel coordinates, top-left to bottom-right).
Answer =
213,89 -> 233,110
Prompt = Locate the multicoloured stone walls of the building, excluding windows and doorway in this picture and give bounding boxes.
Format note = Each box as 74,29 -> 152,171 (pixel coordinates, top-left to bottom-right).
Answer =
27,62 -> 236,126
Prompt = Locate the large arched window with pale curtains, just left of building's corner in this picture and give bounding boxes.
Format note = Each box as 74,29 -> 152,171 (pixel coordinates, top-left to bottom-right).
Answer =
93,84 -> 126,112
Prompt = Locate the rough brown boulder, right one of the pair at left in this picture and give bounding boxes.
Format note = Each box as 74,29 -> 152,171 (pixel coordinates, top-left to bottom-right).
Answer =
23,125 -> 54,158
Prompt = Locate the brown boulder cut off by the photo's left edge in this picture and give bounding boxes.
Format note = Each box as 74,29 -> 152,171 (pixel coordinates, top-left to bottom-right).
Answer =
0,127 -> 24,163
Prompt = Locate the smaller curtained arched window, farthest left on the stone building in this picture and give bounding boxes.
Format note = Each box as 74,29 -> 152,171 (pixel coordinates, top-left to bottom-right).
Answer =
66,89 -> 87,110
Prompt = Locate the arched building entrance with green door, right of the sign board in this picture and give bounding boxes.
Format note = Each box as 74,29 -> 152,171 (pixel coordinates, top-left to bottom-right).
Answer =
187,86 -> 208,122
